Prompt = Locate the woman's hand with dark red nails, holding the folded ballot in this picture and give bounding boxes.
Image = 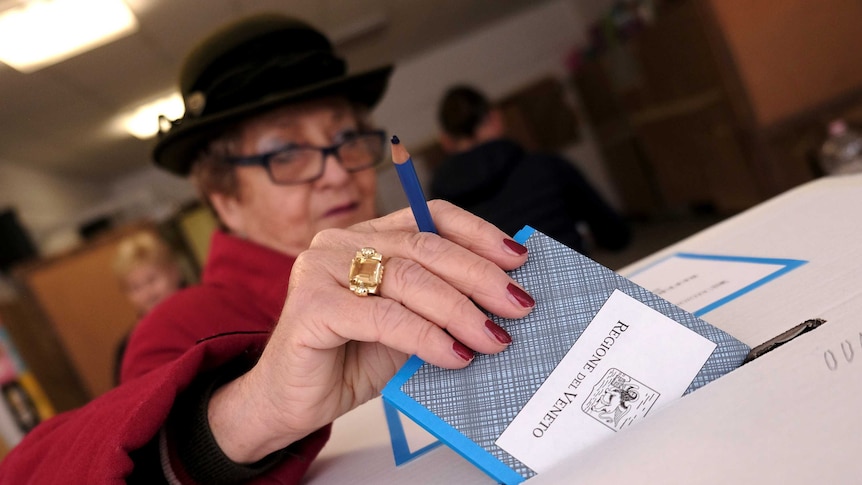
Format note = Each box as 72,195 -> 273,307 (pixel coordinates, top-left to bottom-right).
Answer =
209,201 -> 533,462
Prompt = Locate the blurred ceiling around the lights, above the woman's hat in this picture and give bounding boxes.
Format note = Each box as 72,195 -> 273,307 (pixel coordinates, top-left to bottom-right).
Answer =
0,0 -> 556,183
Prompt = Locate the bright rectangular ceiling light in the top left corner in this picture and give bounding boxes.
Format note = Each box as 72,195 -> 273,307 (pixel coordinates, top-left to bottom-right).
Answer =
0,0 -> 138,73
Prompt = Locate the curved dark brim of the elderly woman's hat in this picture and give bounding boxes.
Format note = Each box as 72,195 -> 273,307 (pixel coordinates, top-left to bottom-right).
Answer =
153,66 -> 392,175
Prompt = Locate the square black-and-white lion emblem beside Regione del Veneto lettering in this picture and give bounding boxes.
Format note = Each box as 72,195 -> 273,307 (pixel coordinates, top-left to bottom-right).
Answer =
581,368 -> 660,431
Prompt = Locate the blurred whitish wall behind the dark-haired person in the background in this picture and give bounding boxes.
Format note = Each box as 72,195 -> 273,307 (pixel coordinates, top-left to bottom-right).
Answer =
374,0 -> 618,213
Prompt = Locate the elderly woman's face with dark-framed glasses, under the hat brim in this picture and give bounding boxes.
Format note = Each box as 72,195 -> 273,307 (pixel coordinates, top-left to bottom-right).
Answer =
212,100 -> 377,255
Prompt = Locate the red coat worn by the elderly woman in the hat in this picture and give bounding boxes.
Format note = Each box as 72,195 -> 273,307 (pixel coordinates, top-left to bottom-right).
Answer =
0,233 -> 329,485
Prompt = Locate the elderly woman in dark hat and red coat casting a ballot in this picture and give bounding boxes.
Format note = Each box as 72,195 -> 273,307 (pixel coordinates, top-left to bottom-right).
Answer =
0,16 -> 533,484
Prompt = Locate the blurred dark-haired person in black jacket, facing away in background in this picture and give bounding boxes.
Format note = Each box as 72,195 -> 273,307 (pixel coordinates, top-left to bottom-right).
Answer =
430,85 -> 630,253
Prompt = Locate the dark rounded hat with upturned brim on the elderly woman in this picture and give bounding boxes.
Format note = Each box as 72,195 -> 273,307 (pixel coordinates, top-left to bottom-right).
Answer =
153,14 -> 392,175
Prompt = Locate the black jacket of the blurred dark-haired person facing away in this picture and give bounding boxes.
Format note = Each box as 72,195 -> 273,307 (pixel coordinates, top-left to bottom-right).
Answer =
431,139 -> 630,252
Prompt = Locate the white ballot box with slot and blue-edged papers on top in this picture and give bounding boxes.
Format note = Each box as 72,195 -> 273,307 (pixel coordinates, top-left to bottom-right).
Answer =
306,175 -> 862,485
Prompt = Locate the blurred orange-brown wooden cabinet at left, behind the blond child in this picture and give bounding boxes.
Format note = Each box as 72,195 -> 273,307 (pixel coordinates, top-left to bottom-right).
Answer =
0,203 -> 216,411
